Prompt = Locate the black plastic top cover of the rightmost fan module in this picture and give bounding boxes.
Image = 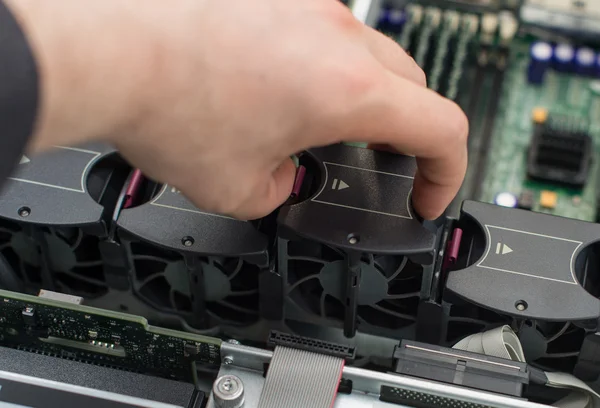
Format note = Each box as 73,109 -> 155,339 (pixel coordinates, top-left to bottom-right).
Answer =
446,201 -> 600,325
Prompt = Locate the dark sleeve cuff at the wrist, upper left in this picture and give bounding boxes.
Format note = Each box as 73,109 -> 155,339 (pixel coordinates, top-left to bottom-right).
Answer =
0,0 -> 39,186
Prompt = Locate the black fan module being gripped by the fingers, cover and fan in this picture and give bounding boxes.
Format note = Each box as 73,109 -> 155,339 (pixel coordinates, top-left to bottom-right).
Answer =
278,144 -> 436,337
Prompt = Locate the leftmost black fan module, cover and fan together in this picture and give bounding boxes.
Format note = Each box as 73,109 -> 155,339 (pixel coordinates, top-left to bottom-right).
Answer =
0,144 -> 130,298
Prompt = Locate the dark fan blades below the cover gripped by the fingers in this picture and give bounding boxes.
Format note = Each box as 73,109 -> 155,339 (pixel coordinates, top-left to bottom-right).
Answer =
279,239 -> 423,336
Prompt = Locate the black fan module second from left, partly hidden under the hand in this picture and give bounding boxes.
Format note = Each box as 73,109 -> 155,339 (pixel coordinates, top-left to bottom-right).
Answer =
117,177 -> 270,330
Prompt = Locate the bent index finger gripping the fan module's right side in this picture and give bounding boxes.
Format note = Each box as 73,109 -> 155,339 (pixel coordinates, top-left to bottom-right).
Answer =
345,73 -> 469,219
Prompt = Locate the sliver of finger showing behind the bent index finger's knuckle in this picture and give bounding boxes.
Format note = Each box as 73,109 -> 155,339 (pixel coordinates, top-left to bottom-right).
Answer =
364,26 -> 427,87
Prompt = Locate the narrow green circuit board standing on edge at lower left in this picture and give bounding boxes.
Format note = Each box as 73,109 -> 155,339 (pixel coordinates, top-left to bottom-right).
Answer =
0,290 -> 221,383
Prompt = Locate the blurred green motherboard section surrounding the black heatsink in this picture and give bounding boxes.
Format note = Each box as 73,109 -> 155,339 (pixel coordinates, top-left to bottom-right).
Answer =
475,39 -> 600,221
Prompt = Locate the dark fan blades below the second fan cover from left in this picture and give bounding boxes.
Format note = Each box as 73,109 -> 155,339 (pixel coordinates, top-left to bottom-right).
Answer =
130,243 -> 259,329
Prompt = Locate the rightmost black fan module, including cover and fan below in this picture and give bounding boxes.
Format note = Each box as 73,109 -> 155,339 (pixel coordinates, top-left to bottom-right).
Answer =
443,201 -> 600,372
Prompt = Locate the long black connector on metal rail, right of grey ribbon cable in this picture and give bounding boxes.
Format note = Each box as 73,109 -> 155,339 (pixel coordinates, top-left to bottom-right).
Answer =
394,340 -> 529,397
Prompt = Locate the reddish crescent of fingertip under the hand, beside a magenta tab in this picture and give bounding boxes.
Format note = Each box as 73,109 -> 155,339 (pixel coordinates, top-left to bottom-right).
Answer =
233,158 -> 296,220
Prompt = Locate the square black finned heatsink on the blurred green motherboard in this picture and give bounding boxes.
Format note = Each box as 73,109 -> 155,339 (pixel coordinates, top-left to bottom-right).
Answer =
527,116 -> 593,187
